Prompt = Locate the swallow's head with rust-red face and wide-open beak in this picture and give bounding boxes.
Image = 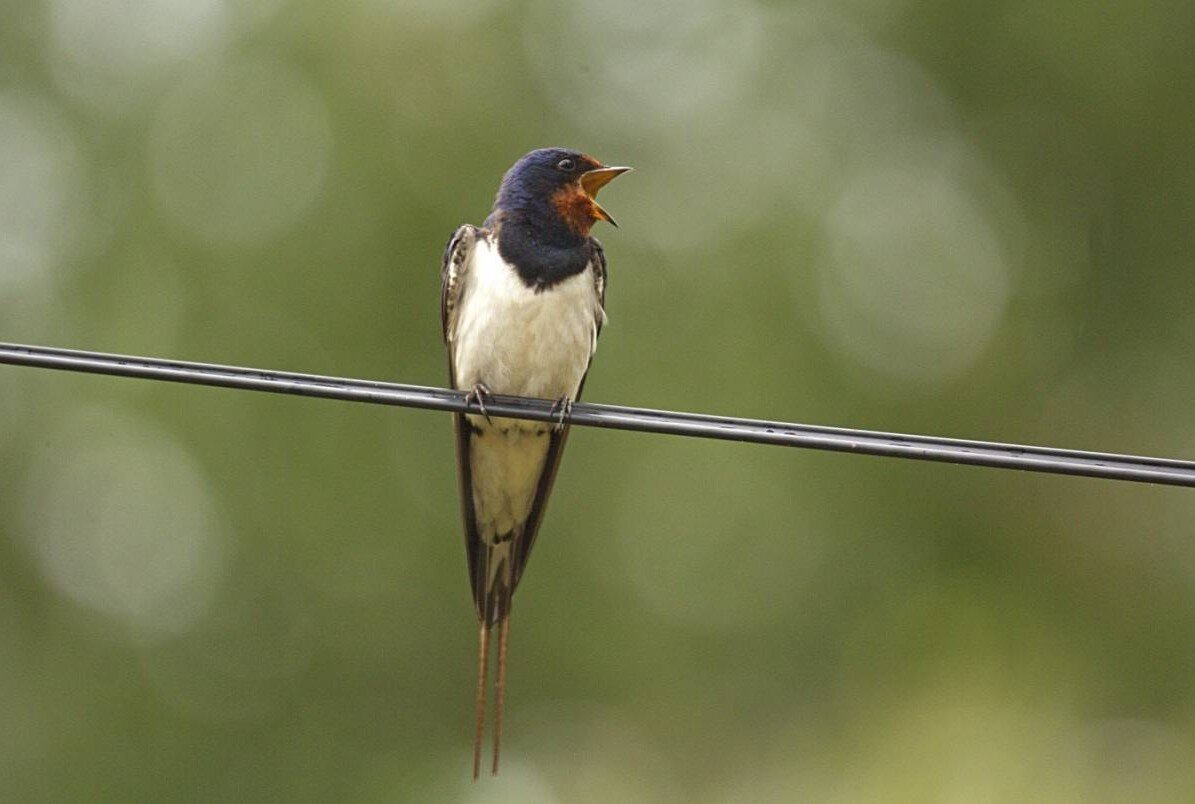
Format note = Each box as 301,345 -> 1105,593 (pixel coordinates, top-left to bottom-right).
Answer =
494,148 -> 631,237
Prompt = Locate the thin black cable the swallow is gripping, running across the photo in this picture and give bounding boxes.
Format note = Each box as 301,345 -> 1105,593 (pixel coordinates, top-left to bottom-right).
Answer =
0,343 -> 1195,486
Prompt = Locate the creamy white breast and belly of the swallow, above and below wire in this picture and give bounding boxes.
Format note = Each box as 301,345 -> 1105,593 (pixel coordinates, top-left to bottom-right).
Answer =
449,240 -> 603,544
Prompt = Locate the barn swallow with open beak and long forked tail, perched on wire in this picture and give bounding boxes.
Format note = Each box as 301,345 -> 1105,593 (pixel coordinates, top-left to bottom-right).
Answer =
440,148 -> 631,780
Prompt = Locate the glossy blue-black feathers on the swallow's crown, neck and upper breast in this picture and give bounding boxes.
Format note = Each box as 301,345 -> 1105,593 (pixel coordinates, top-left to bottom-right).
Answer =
485,148 -> 600,289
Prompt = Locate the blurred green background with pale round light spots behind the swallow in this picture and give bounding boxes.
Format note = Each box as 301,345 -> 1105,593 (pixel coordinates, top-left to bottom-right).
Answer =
0,0 -> 1195,802
